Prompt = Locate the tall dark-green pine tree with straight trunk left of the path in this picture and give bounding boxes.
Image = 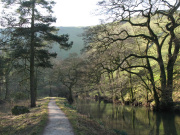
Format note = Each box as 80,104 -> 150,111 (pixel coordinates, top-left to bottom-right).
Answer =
0,0 -> 72,107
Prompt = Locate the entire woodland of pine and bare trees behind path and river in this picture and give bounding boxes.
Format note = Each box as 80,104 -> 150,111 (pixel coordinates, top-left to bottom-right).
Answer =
0,0 -> 180,110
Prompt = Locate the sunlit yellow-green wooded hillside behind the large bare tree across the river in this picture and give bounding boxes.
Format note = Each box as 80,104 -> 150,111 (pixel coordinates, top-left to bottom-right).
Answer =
77,11 -> 180,109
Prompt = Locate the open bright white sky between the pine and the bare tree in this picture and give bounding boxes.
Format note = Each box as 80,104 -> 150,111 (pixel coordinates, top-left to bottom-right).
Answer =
53,0 -> 100,27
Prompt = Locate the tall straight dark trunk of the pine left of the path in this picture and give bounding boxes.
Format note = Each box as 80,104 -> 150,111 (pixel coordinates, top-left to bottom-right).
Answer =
30,0 -> 36,107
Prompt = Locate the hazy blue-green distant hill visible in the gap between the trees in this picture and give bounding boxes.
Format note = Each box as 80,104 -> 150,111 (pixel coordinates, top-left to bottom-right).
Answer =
51,27 -> 84,59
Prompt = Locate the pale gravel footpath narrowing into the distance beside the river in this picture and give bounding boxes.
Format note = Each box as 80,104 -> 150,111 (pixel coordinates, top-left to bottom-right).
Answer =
43,98 -> 74,135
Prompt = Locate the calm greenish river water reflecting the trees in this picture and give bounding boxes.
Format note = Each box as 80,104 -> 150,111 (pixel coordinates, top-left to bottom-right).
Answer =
75,99 -> 180,135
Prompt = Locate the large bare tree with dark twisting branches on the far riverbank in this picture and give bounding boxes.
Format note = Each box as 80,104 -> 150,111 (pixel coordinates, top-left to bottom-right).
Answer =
99,0 -> 180,109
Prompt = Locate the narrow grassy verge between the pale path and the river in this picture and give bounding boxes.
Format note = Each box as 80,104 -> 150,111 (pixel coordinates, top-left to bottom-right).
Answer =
56,98 -> 116,135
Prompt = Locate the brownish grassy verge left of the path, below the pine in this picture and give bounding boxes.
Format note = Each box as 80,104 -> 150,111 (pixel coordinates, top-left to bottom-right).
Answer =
0,98 -> 49,135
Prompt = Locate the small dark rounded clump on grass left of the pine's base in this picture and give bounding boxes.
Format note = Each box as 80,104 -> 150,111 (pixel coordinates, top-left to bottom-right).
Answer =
11,106 -> 30,115
